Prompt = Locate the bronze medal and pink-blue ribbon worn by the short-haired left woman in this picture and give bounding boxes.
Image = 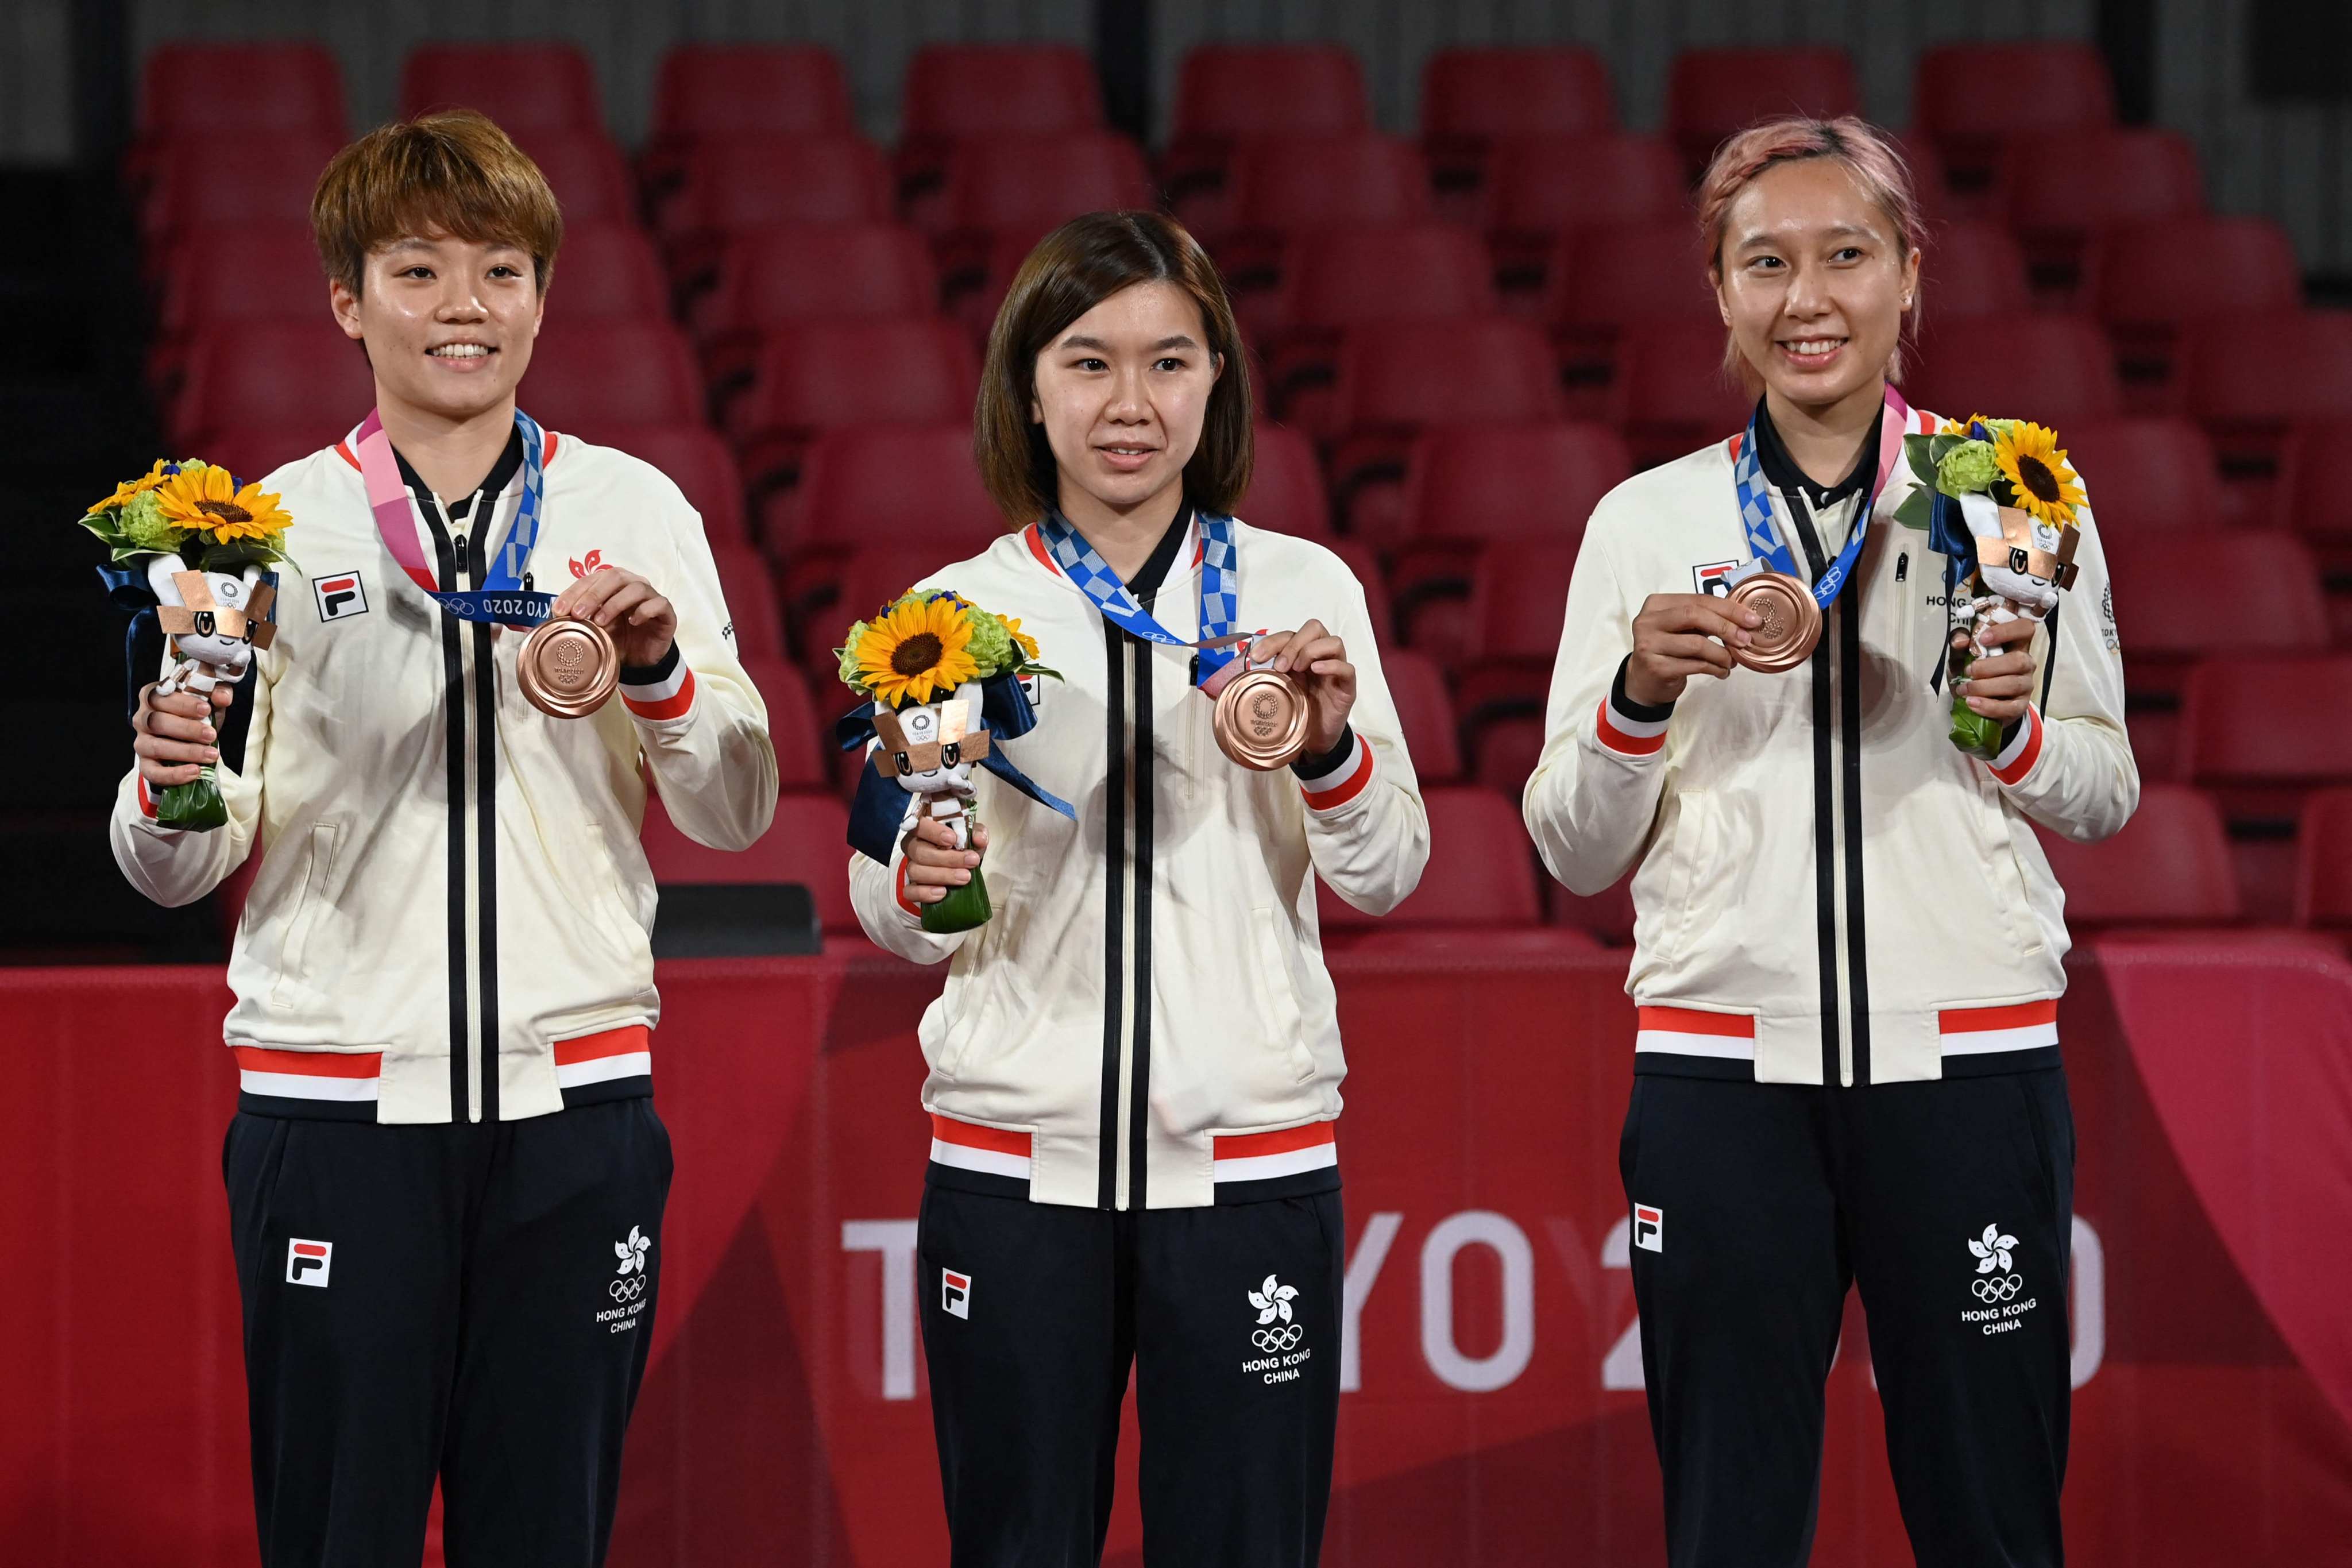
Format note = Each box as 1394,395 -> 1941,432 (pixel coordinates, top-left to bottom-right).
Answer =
350,409 -> 621,719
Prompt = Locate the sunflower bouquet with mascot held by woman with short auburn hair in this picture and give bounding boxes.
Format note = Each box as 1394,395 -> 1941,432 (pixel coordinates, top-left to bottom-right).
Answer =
82,458 -> 292,830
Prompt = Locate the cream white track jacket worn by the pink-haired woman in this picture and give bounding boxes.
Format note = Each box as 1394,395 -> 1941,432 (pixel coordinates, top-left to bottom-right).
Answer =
1524,411 -> 2140,1084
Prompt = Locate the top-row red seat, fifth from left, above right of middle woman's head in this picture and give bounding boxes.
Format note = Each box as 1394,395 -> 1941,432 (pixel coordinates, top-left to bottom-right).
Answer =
1160,45 -> 1371,211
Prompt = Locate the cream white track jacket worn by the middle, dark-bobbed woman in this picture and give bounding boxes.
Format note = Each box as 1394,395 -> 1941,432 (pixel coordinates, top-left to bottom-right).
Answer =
849,520 -> 1430,1208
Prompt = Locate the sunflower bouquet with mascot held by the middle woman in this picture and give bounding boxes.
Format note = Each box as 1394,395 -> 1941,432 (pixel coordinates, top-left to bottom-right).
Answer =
835,588 -> 1068,931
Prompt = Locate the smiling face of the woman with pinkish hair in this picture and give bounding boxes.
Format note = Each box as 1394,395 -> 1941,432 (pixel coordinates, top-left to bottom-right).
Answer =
1714,157 -> 1920,411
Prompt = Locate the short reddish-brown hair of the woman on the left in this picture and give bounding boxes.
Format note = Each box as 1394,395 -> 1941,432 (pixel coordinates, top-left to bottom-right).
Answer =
311,108 -> 565,294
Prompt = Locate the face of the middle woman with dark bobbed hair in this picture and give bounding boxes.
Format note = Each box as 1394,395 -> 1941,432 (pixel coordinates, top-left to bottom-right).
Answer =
1030,282 -> 1223,522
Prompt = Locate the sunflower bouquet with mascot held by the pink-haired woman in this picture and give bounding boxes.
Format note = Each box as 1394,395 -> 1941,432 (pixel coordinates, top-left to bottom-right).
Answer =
1896,414 -> 2084,759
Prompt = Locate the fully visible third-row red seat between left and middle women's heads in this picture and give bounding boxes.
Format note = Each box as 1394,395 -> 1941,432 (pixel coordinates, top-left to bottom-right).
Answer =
692,223 -> 939,385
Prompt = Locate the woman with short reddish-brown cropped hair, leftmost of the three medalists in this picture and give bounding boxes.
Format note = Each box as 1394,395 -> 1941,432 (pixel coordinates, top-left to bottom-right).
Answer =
110,110 -> 776,1568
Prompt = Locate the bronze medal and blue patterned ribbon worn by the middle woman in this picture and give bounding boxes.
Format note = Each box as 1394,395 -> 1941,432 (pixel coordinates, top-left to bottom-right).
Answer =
1037,512 -> 1308,771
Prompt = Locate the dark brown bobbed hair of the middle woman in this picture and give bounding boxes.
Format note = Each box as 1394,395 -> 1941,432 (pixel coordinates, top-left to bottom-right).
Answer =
971,211 -> 1252,529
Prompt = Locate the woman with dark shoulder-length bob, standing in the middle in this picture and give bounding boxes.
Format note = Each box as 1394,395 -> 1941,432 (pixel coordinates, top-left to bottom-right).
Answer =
849,211 -> 1428,1568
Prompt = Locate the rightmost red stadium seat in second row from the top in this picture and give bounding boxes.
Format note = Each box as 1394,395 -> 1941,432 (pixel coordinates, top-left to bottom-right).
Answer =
2002,127 -> 2204,294
